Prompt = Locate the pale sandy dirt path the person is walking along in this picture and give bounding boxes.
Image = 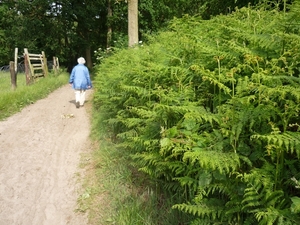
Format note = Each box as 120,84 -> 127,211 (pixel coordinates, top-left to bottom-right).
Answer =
0,85 -> 90,225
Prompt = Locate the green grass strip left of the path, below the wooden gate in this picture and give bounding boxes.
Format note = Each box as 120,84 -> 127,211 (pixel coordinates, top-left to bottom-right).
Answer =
0,72 -> 69,120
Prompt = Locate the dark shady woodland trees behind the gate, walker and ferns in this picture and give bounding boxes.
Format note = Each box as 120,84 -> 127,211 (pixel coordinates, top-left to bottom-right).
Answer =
0,0 -> 259,69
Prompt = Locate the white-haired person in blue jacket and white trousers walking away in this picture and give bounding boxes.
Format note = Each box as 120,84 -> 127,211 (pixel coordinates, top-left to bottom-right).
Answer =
69,57 -> 92,108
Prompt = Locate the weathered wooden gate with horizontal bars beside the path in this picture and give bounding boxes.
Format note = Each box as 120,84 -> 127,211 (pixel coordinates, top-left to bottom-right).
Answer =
24,48 -> 48,84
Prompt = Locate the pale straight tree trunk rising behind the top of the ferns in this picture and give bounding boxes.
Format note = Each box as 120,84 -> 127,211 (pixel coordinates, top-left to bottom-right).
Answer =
128,0 -> 139,47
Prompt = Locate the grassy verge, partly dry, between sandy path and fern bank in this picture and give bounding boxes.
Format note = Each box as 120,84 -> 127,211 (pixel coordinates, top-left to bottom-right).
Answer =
78,110 -> 188,225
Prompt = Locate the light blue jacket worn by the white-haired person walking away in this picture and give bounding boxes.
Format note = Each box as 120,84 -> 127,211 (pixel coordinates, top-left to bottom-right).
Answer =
69,64 -> 92,90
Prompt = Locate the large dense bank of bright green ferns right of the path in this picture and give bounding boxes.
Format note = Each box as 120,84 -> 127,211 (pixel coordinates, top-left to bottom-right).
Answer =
94,3 -> 300,225
